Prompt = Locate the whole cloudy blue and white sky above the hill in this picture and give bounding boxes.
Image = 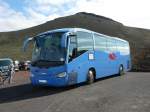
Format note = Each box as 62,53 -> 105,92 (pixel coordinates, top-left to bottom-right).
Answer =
0,0 -> 150,32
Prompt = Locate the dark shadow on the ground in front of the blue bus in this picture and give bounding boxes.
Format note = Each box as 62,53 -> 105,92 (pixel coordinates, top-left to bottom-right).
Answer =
0,84 -> 77,104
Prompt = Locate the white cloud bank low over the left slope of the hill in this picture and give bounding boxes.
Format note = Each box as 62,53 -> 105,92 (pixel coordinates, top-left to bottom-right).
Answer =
0,1 -> 62,32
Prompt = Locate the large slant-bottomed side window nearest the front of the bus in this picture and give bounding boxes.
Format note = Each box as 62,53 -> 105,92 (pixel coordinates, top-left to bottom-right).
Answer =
77,32 -> 93,55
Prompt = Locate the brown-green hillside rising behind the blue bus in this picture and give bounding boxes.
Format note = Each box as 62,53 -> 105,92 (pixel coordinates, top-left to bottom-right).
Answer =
0,12 -> 150,71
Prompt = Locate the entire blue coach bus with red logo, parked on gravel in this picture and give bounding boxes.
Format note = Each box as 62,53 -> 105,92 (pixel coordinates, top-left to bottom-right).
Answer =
24,28 -> 131,87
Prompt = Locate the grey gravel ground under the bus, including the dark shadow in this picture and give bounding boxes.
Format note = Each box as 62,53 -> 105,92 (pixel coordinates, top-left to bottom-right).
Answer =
0,72 -> 150,112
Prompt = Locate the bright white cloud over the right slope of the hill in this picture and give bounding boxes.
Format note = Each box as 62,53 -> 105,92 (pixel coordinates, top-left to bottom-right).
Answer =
71,0 -> 150,29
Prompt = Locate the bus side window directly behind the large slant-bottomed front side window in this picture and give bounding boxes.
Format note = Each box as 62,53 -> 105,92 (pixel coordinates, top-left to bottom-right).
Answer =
94,34 -> 106,51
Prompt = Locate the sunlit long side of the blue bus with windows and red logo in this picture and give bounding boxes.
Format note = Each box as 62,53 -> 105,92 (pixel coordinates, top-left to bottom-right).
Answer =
67,31 -> 131,83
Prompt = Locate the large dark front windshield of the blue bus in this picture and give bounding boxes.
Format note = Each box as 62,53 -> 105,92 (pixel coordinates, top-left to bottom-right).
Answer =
32,32 -> 66,66
